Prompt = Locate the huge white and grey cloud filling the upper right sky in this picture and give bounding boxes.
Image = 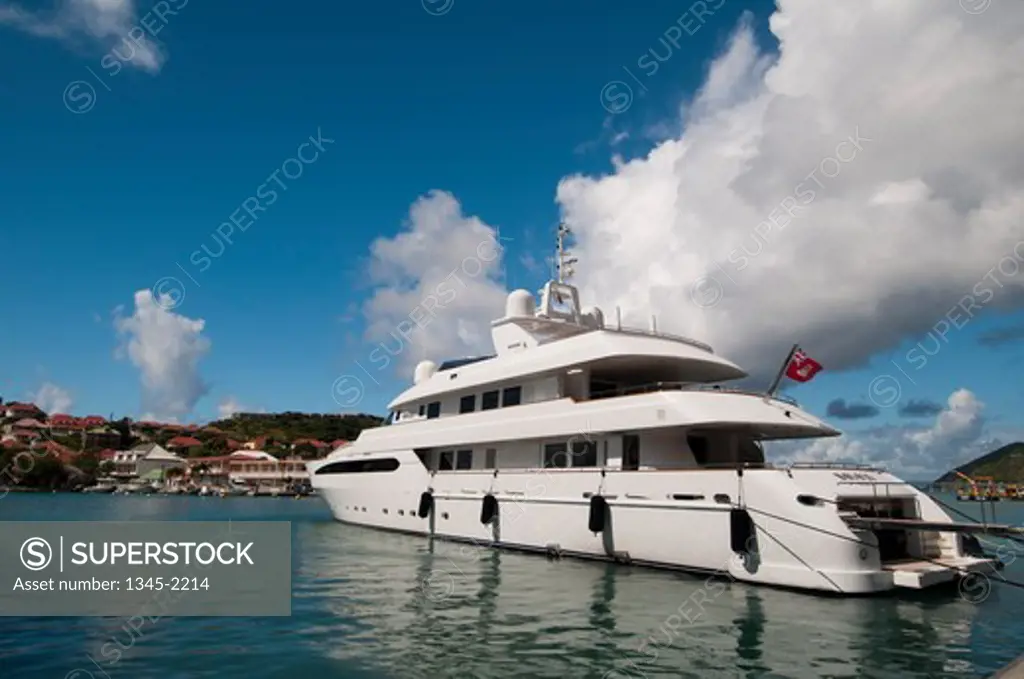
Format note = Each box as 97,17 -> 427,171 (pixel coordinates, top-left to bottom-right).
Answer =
557,0 -> 1024,380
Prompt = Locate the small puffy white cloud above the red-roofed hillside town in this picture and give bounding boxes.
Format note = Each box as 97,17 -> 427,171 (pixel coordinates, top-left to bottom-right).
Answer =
114,290 -> 210,421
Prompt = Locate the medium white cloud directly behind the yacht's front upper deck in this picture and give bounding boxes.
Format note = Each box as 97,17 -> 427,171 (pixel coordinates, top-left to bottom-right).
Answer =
362,192 -> 507,378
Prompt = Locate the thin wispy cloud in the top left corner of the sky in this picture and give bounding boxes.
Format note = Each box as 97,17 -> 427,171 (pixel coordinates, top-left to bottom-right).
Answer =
0,0 -> 163,73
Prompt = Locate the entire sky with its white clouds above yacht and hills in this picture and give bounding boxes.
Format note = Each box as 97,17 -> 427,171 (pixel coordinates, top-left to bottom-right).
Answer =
0,0 -> 1024,478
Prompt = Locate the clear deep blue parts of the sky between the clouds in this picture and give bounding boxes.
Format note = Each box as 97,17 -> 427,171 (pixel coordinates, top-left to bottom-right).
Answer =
0,0 -> 1024,473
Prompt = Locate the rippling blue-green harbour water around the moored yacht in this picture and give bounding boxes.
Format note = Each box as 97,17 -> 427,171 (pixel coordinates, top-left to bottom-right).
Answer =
0,495 -> 1024,679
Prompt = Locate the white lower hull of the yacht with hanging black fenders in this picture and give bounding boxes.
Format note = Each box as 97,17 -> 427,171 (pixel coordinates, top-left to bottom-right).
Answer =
312,451 -> 992,594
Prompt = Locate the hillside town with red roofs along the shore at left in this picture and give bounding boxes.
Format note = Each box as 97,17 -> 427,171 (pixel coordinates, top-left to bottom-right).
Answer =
0,400 -> 374,496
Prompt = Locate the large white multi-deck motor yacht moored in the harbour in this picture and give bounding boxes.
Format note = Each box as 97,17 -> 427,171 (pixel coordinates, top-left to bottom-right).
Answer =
309,229 -> 997,594
